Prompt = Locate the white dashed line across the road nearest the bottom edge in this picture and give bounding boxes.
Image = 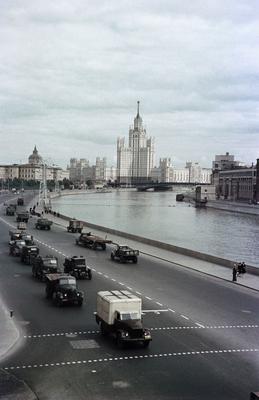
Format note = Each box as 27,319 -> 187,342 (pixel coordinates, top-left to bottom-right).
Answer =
3,348 -> 259,371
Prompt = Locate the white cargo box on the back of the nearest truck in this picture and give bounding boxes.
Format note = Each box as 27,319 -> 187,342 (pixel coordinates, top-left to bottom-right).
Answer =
97,290 -> 142,325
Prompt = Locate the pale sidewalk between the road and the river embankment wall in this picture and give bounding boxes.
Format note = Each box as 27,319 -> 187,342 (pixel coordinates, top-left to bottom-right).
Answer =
43,214 -> 259,291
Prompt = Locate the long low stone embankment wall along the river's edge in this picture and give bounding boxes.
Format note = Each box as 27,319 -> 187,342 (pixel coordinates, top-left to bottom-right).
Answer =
52,214 -> 259,275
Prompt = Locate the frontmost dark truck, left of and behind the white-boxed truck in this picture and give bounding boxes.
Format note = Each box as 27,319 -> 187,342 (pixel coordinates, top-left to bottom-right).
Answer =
46,274 -> 84,307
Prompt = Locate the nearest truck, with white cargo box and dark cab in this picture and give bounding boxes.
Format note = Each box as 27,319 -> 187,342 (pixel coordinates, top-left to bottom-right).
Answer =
95,290 -> 152,347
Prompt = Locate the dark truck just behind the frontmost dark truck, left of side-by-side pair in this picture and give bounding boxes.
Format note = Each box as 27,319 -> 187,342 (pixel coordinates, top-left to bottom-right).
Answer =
32,255 -> 61,282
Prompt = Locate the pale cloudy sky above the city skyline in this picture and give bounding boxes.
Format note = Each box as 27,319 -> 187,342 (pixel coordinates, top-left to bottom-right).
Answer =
0,0 -> 259,167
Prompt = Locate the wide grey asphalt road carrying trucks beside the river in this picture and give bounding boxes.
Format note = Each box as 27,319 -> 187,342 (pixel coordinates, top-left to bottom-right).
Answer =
0,193 -> 259,400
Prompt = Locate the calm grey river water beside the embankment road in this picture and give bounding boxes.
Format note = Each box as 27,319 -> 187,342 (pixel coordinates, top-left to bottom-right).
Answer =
52,190 -> 259,268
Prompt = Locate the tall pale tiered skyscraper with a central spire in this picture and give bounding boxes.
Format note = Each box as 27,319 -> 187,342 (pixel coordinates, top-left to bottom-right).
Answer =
117,101 -> 155,184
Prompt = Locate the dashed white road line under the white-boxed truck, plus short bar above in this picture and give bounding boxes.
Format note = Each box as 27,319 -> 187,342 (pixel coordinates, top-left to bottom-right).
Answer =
23,324 -> 259,339
